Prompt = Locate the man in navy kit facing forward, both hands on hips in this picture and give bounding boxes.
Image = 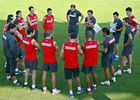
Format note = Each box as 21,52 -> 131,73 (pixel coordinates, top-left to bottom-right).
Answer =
66,5 -> 84,41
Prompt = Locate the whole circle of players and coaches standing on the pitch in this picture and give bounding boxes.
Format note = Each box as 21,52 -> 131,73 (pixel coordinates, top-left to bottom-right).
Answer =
3,5 -> 139,98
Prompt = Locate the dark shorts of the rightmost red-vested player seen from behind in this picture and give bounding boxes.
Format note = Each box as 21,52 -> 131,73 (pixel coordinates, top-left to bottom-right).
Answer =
82,65 -> 97,74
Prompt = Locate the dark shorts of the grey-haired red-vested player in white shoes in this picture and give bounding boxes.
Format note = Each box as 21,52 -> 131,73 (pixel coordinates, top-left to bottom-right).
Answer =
43,62 -> 58,72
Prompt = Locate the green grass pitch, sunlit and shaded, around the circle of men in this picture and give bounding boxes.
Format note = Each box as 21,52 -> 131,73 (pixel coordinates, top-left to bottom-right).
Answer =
0,0 -> 140,100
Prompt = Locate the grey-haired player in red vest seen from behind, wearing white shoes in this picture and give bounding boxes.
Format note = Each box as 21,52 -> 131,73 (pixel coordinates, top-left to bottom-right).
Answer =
41,29 -> 61,95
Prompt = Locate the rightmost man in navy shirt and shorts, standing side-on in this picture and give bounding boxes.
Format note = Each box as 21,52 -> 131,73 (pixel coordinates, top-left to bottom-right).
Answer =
115,18 -> 138,75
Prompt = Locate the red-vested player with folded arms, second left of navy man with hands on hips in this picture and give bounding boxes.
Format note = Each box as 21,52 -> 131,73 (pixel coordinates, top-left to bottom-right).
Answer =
27,6 -> 39,41
